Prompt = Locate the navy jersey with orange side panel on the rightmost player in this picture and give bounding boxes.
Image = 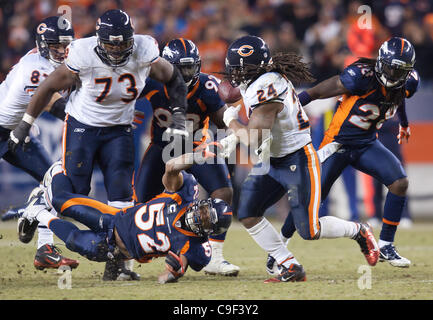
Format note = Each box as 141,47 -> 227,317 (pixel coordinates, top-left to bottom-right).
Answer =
320,64 -> 419,148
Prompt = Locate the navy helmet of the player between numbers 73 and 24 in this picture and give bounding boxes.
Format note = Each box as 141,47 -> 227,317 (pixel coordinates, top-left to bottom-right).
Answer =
162,38 -> 201,89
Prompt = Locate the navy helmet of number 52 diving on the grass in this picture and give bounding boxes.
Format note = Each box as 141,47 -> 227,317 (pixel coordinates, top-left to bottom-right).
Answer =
185,198 -> 233,237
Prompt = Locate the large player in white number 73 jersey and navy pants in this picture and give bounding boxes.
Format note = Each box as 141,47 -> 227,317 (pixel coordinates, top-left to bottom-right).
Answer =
11,9 -> 187,280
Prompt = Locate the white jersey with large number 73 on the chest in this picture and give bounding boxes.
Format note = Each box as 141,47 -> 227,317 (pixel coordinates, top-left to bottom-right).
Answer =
65,35 -> 159,127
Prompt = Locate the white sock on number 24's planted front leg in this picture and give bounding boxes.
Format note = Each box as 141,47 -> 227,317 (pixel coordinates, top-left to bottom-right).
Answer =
247,218 -> 299,268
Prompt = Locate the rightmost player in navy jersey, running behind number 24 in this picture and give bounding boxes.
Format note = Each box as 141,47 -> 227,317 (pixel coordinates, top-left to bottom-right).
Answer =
282,37 -> 419,267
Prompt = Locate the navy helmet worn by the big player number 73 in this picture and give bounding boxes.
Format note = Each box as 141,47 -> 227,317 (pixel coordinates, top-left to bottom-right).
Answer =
96,9 -> 134,67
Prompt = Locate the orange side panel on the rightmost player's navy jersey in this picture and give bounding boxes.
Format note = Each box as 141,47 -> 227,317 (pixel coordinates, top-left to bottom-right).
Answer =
319,89 -> 376,149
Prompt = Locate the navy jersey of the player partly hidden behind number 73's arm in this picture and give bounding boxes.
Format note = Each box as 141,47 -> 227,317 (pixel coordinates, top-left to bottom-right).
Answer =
141,73 -> 224,145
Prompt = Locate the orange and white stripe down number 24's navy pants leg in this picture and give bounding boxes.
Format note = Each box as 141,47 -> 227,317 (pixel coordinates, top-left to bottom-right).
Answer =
304,143 -> 321,238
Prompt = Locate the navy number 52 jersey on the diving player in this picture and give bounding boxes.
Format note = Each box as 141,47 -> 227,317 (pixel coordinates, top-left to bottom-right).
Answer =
115,172 -> 211,271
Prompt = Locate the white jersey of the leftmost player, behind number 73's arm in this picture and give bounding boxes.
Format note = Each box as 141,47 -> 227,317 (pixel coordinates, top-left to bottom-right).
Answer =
0,48 -> 54,130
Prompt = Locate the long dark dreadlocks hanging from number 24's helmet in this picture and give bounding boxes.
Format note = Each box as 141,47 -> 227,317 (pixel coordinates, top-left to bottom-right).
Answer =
221,52 -> 315,84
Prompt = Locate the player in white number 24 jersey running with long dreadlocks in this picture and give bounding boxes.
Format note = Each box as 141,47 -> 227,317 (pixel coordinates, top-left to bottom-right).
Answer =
220,36 -> 378,282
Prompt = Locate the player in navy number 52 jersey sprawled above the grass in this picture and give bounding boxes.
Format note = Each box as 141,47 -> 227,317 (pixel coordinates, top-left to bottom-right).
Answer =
16,153 -> 232,283
